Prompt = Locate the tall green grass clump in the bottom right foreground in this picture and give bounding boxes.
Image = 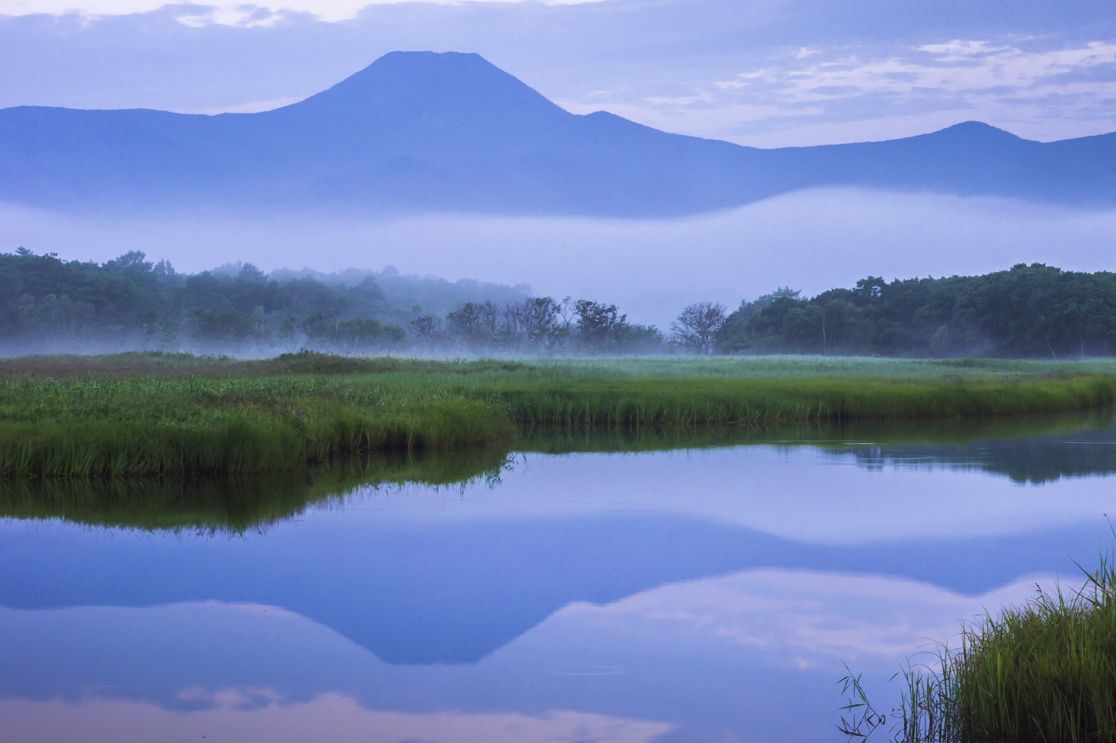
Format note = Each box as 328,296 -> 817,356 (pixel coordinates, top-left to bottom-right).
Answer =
843,546 -> 1116,743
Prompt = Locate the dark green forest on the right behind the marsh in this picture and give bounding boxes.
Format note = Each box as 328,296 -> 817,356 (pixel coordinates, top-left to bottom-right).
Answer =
715,263 -> 1116,358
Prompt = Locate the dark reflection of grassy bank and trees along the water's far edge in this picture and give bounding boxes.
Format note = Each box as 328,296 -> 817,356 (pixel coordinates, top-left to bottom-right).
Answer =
0,413 -> 1116,533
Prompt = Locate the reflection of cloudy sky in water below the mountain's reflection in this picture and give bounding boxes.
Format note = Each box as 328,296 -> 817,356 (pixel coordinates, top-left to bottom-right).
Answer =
0,571 -> 1062,742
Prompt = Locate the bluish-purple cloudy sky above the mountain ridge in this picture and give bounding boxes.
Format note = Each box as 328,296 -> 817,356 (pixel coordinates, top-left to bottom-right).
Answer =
0,0 -> 1116,146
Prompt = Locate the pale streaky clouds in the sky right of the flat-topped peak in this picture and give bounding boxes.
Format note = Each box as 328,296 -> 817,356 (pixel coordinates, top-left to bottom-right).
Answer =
602,38 -> 1116,144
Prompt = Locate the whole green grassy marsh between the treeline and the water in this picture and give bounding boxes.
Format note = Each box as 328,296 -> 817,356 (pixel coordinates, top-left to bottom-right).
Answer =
0,354 -> 1116,479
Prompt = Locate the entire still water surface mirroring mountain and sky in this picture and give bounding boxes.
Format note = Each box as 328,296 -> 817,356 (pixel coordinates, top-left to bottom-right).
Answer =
0,422 -> 1116,743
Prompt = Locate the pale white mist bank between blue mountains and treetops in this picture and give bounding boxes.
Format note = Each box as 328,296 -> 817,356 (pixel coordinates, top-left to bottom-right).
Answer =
0,190 -> 1116,327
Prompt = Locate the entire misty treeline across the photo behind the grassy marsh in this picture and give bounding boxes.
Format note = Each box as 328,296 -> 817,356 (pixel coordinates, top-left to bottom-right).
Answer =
0,249 -> 1116,358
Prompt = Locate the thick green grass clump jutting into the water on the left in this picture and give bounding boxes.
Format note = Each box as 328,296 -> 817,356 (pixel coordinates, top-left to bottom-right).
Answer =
0,375 -> 513,479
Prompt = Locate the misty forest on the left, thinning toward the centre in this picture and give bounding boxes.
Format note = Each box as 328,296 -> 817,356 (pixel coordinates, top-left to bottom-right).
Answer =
0,249 -> 665,354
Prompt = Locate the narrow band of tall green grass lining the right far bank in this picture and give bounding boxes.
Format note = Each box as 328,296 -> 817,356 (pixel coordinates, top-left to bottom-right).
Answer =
487,375 -> 1116,427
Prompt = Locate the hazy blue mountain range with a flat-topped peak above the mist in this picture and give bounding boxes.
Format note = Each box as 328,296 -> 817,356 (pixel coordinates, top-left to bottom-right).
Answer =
0,52 -> 1116,216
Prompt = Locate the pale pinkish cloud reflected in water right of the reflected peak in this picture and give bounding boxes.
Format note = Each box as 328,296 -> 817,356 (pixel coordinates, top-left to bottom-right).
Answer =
558,569 -> 1057,670
